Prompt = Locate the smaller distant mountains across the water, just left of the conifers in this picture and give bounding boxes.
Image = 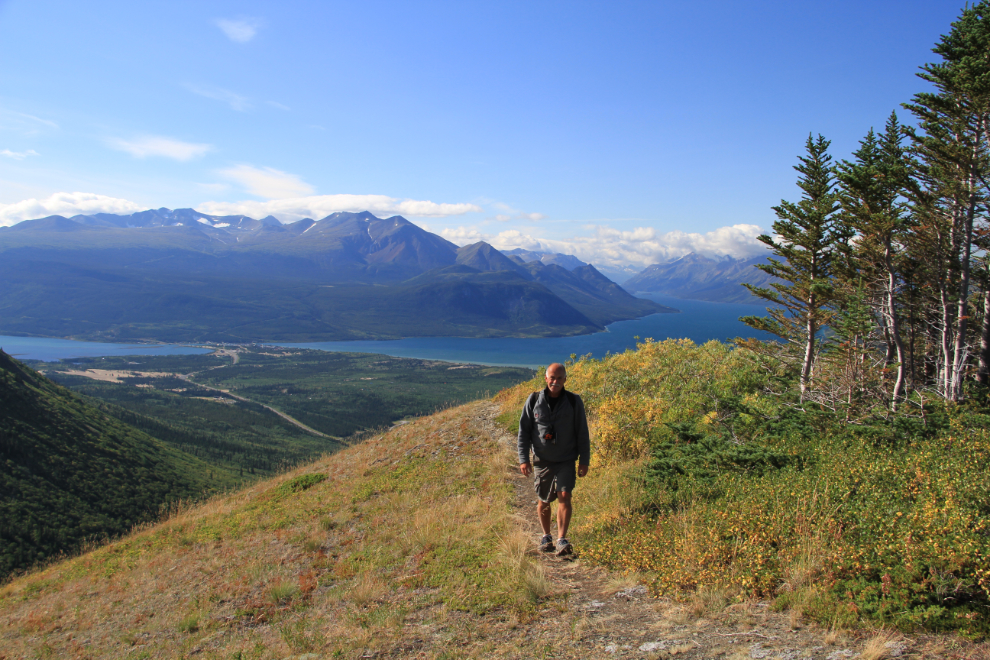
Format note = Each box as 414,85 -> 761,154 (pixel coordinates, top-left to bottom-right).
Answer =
623,252 -> 775,304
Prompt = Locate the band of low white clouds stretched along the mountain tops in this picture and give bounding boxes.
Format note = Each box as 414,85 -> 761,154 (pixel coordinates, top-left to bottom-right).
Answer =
0,191 -> 766,273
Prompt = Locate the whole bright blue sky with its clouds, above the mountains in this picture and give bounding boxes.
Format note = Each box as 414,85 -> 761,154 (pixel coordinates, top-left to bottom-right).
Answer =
0,0 -> 976,271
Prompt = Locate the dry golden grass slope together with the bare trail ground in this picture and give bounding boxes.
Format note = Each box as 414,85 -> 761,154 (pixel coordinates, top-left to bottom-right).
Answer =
0,402 -> 986,660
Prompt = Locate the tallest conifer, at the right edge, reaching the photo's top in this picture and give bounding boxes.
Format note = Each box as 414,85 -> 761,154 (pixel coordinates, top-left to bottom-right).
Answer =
905,0 -> 990,400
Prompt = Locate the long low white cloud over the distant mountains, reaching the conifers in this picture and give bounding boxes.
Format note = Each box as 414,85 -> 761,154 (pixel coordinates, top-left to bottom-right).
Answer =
440,225 -> 766,269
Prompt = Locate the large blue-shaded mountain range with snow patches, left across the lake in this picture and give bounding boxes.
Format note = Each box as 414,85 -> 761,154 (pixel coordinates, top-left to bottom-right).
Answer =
0,208 -> 676,342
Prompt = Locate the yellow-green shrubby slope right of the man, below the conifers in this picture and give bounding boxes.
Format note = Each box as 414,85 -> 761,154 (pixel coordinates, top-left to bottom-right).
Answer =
500,340 -> 990,637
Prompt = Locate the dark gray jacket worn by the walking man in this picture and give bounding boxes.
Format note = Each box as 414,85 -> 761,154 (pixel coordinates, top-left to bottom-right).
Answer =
517,388 -> 591,465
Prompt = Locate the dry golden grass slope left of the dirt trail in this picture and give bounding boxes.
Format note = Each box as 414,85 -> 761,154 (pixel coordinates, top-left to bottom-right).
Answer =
0,404 -> 546,658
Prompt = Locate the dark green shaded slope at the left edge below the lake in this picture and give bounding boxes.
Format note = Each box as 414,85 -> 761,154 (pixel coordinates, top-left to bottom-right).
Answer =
0,352 -> 233,576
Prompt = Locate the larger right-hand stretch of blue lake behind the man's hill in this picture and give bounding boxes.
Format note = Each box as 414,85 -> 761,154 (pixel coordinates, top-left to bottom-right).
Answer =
278,295 -> 772,368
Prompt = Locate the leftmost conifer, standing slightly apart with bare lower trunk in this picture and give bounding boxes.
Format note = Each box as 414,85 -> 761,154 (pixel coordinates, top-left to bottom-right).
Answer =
740,135 -> 848,401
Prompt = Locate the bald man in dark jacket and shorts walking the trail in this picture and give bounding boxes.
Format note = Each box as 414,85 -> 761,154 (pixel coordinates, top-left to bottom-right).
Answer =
518,363 -> 591,557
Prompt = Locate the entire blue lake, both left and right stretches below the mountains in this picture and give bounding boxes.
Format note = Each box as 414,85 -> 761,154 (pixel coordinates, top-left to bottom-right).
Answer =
0,296 -> 771,367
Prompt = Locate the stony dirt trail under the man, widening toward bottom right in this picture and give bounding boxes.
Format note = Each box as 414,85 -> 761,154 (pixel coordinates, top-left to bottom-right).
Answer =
474,404 -> 990,660
